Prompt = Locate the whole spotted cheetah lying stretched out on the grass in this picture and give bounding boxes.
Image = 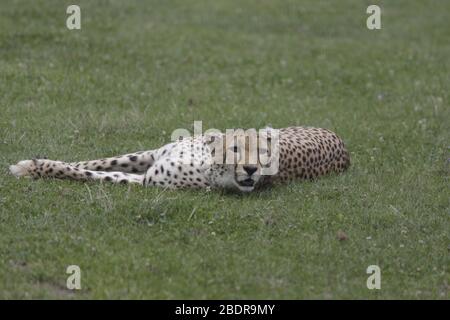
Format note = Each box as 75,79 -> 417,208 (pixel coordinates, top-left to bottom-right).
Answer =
9,127 -> 350,192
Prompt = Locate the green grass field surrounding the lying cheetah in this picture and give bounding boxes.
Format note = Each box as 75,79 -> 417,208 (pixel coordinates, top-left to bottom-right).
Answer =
0,0 -> 450,299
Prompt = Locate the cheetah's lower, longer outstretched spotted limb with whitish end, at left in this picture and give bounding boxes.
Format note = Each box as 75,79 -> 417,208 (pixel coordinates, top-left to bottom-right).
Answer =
9,159 -> 144,185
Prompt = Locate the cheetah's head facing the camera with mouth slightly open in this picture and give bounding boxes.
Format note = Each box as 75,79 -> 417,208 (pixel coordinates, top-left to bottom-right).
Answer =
208,129 -> 278,192
